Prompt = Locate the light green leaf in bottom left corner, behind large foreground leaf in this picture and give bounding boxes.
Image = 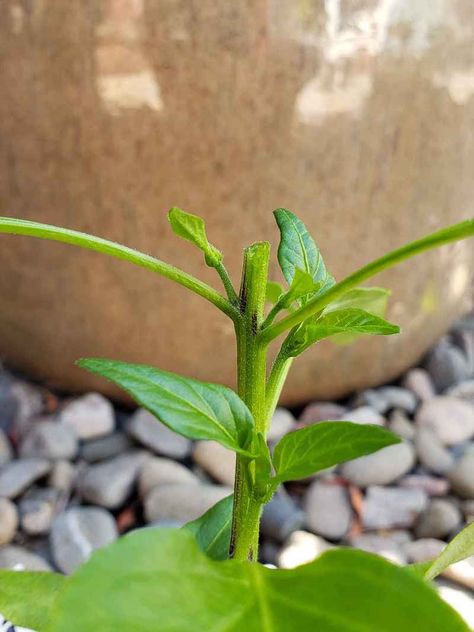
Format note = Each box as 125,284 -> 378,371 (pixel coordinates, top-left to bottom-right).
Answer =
0,570 -> 66,632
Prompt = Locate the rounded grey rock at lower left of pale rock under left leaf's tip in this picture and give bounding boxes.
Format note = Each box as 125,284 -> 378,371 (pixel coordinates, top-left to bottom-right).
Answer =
20,421 -> 78,460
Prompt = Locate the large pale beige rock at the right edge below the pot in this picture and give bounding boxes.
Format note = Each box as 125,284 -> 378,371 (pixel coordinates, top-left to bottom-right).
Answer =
416,396 -> 474,445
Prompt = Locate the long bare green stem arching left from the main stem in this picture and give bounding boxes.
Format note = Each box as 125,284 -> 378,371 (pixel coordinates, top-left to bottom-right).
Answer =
0,217 -> 238,321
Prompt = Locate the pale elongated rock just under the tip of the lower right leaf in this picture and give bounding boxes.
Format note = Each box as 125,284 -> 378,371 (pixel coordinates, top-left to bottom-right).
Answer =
341,442 -> 415,487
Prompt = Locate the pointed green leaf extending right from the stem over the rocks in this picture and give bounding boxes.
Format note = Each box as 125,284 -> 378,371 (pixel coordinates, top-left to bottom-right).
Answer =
273,421 -> 400,483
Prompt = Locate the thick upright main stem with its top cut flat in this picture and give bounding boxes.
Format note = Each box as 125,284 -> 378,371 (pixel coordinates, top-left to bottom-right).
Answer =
230,242 -> 270,560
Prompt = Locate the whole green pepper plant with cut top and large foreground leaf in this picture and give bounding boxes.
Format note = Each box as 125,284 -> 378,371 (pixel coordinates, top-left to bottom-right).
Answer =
0,208 -> 474,632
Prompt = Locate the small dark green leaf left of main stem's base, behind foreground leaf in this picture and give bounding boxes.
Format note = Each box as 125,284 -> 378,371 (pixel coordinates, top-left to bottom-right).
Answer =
183,494 -> 234,560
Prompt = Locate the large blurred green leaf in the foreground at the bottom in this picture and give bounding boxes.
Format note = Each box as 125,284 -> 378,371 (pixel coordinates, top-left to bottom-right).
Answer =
49,529 -> 468,632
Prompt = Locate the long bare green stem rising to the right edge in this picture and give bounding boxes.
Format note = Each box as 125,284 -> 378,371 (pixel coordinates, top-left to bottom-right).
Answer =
259,219 -> 474,344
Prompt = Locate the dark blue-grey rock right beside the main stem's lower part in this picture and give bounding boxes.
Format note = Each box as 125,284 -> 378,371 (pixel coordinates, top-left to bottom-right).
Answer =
261,491 -> 305,542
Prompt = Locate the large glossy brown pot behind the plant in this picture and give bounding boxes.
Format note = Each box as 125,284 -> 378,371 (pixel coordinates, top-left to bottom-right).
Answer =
0,0 -> 474,402
